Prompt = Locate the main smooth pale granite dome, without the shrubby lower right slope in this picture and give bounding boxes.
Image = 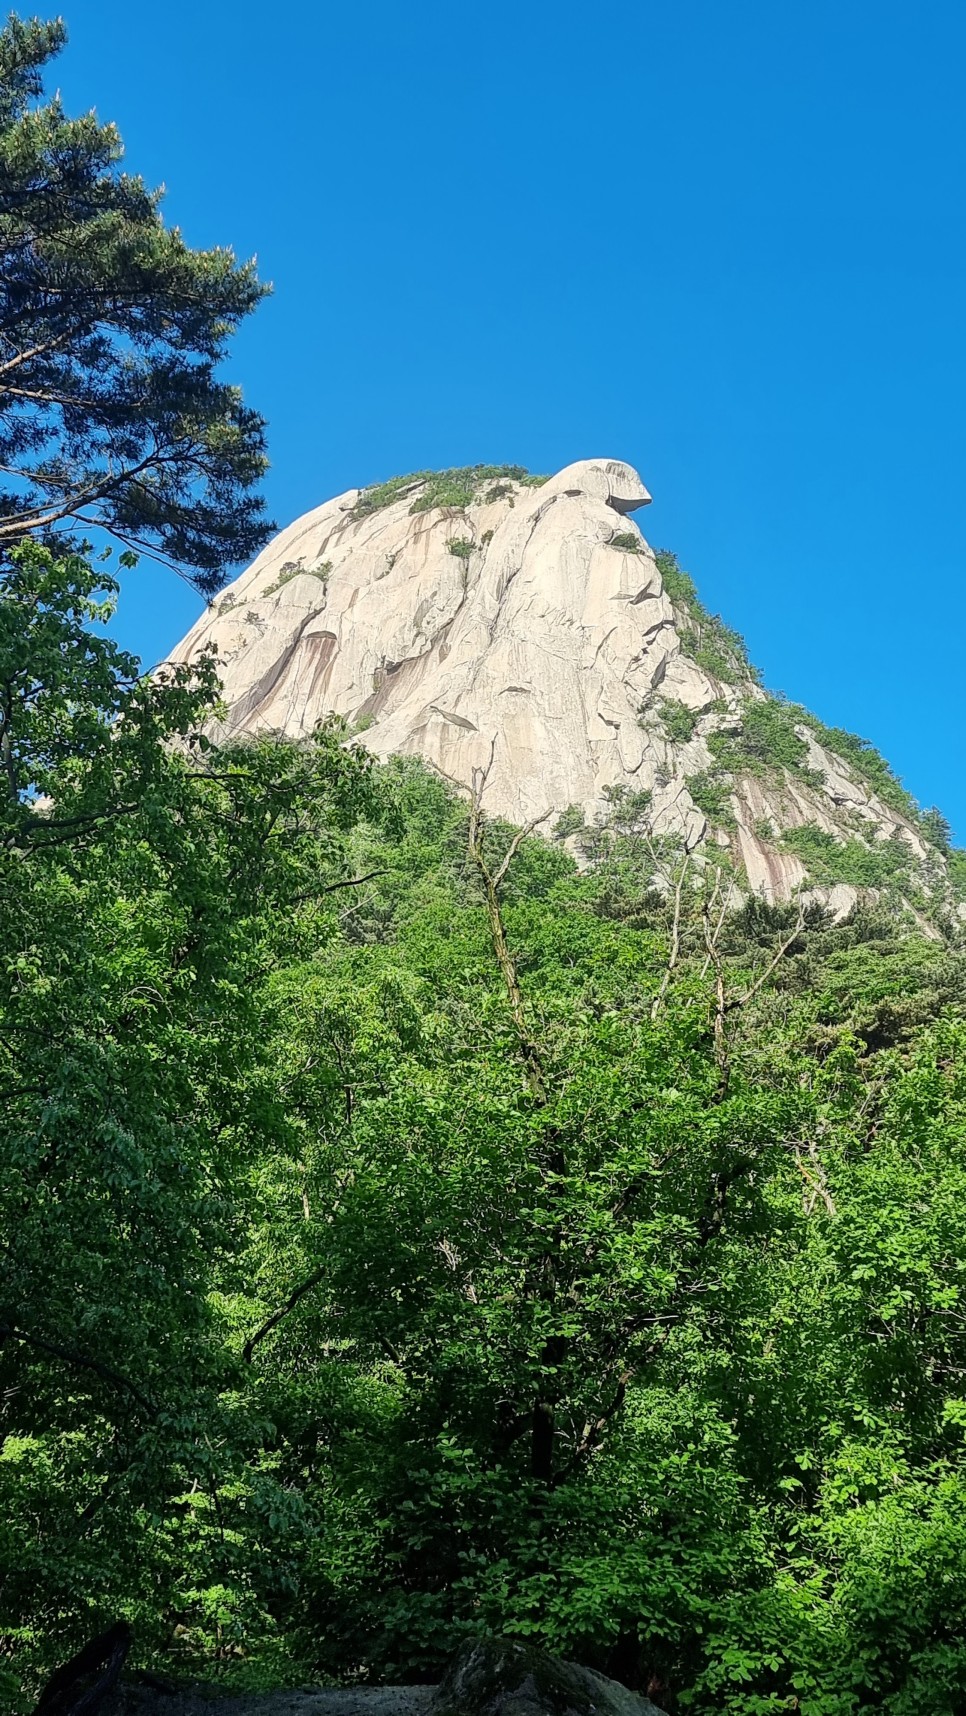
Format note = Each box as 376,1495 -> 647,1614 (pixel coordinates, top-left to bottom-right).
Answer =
169,460 -> 682,822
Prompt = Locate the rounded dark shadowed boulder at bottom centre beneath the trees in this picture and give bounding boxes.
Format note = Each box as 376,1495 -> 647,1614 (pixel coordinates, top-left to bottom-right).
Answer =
429,1639 -> 666,1716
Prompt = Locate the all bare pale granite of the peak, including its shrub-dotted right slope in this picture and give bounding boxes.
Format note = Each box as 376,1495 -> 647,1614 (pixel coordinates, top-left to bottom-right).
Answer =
173,458 -> 953,913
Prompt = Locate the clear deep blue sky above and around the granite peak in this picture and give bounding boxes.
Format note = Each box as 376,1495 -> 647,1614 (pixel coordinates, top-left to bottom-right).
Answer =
51,0 -> 966,843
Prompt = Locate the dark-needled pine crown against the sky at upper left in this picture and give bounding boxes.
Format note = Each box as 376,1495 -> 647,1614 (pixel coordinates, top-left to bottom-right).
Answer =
0,15 -> 273,594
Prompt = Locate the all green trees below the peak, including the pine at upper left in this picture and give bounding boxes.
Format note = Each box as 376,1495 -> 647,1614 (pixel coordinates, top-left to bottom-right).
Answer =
0,22 -> 966,1716
